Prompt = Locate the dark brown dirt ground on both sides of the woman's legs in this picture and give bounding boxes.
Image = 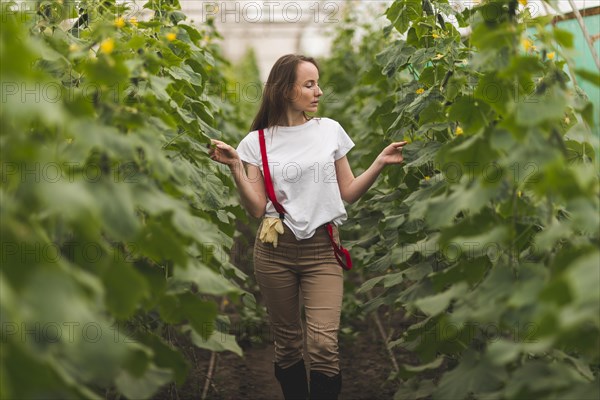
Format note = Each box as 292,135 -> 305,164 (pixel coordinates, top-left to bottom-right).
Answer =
154,323 -> 397,400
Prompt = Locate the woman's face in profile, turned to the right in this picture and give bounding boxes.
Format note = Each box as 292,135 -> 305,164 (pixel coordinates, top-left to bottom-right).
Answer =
290,61 -> 323,112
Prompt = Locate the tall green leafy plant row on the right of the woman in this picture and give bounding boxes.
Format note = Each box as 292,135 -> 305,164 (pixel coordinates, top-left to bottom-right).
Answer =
323,0 -> 600,399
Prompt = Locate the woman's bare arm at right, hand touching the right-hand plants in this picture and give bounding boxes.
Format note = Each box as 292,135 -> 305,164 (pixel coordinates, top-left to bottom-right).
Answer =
335,142 -> 407,203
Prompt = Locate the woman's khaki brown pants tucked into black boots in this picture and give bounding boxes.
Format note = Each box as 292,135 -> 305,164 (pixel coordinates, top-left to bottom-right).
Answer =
254,220 -> 344,376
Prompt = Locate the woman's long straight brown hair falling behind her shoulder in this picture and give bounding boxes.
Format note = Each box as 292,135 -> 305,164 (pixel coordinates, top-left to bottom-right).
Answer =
250,54 -> 319,131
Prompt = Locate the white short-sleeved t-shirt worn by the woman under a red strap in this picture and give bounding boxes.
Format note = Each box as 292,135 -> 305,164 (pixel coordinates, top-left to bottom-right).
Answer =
237,118 -> 354,239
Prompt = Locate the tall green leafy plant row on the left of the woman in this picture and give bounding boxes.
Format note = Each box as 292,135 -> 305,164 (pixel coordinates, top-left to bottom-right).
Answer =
0,1 -> 246,398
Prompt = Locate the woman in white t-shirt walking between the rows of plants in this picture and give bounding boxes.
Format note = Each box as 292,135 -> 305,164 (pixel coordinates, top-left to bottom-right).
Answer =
209,55 -> 406,400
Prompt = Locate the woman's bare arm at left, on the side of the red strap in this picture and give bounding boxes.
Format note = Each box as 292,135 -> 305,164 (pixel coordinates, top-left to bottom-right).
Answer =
209,139 -> 267,218
